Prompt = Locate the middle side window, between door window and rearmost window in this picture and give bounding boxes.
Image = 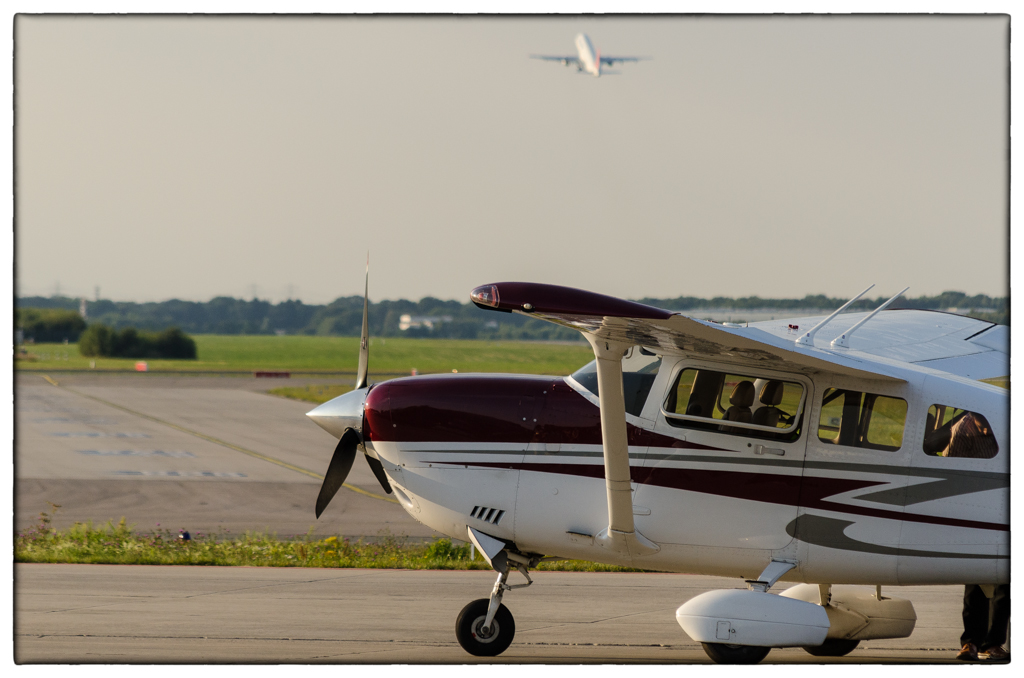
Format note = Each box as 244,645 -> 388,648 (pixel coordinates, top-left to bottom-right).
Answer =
818,388 -> 906,451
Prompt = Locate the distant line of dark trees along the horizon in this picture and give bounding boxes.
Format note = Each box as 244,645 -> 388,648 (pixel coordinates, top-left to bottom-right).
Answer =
17,292 -> 1010,341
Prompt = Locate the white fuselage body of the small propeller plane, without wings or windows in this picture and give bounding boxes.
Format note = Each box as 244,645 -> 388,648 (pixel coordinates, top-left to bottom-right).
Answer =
367,358 -> 1010,585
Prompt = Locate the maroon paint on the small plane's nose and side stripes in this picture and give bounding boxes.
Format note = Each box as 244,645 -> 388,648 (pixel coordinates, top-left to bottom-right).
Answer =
364,375 -> 1010,532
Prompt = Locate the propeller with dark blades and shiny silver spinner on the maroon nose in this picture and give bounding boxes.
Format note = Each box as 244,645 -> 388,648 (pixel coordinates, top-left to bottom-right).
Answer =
306,257 -> 391,518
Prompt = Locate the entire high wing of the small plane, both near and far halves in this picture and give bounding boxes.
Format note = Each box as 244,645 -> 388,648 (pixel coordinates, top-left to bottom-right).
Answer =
473,283 -> 1010,381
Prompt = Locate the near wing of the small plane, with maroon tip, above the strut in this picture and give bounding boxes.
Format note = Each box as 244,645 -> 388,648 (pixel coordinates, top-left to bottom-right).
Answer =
470,283 -> 904,382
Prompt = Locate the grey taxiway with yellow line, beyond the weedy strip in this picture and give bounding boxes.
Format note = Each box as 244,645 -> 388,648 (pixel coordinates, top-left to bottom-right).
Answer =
14,373 -> 433,538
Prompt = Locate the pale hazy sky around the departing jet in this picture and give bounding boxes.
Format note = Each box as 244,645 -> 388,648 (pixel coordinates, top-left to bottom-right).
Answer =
15,15 -> 1009,303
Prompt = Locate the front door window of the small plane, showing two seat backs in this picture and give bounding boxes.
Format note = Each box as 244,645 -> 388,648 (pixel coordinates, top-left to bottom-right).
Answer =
664,368 -> 804,440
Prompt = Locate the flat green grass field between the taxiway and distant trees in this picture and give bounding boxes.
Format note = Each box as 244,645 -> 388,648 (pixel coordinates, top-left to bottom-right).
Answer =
15,334 -> 594,376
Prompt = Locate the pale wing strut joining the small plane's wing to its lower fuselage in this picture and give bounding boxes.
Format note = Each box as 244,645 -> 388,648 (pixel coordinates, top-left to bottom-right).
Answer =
584,333 -> 660,558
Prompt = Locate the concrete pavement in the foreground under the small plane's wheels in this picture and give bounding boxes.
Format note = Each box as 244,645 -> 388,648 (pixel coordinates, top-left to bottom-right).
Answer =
14,564 -> 963,664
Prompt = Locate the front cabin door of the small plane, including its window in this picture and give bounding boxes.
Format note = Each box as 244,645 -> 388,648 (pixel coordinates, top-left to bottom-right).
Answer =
634,366 -> 813,550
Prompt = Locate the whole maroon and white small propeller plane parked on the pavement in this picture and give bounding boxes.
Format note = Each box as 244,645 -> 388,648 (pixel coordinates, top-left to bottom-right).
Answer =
308,274 -> 1010,664
